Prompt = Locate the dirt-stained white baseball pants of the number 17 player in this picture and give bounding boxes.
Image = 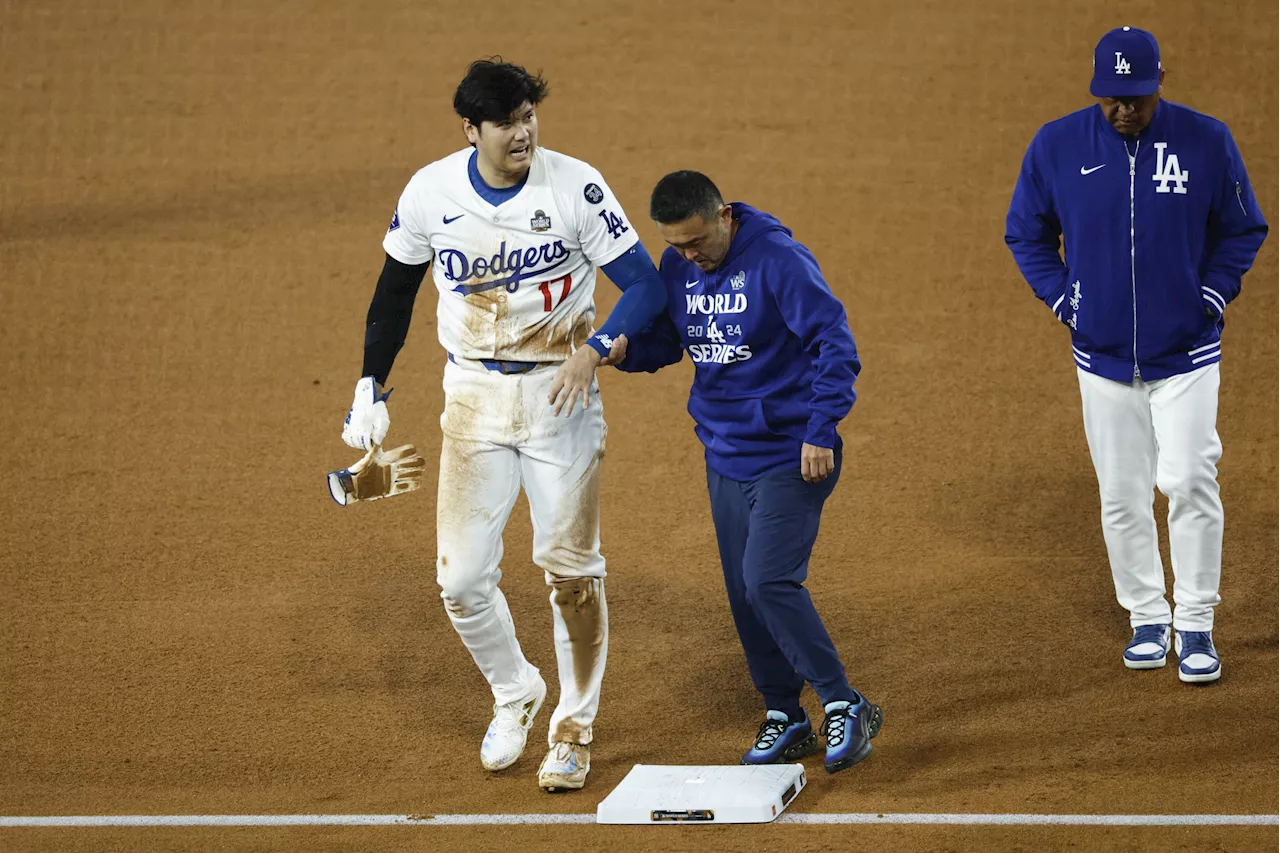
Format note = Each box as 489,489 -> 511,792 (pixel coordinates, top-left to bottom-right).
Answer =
436,361 -> 609,743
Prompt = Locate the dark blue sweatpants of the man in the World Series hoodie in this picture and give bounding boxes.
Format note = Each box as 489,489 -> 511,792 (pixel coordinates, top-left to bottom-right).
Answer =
707,446 -> 858,711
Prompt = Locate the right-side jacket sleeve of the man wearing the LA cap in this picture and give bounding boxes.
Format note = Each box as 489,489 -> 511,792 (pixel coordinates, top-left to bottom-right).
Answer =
1201,122 -> 1267,316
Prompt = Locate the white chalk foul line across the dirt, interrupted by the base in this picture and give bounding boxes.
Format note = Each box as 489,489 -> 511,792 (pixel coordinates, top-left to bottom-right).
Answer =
0,812 -> 1280,827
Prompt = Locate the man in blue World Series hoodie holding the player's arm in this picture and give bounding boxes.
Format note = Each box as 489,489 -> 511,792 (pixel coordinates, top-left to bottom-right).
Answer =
608,172 -> 883,772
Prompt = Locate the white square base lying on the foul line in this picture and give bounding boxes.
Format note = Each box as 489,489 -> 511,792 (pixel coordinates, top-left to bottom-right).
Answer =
595,763 -> 806,824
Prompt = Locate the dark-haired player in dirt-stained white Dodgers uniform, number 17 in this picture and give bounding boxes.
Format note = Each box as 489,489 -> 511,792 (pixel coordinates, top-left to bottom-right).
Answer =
343,58 -> 666,792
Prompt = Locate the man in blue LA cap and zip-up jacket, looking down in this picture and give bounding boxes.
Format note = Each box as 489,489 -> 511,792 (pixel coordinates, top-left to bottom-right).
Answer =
1005,27 -> 1267,683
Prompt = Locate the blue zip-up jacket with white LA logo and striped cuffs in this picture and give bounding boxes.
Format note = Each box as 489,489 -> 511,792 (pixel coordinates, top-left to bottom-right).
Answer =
1005,101 -> 1267,382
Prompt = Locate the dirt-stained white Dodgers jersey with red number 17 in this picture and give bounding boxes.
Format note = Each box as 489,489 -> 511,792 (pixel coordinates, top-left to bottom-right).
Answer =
383,147 -> 639,362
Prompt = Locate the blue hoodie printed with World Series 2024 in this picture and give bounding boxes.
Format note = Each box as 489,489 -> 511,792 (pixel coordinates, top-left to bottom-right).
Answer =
618,202 -> 861,482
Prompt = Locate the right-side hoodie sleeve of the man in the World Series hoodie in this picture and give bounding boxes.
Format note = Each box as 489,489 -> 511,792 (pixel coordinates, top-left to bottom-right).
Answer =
767,245 -> 863,448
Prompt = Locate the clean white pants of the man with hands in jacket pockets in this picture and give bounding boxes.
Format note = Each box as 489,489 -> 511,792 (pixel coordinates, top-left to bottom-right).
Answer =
1076,364 -> 1222,631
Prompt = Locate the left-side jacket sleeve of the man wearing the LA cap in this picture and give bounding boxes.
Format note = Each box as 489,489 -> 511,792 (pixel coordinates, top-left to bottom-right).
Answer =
1005,134 -> 1070,320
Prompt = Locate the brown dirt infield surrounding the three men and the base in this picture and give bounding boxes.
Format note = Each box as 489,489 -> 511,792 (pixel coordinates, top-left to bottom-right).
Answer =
0,0 -> 1280,850
